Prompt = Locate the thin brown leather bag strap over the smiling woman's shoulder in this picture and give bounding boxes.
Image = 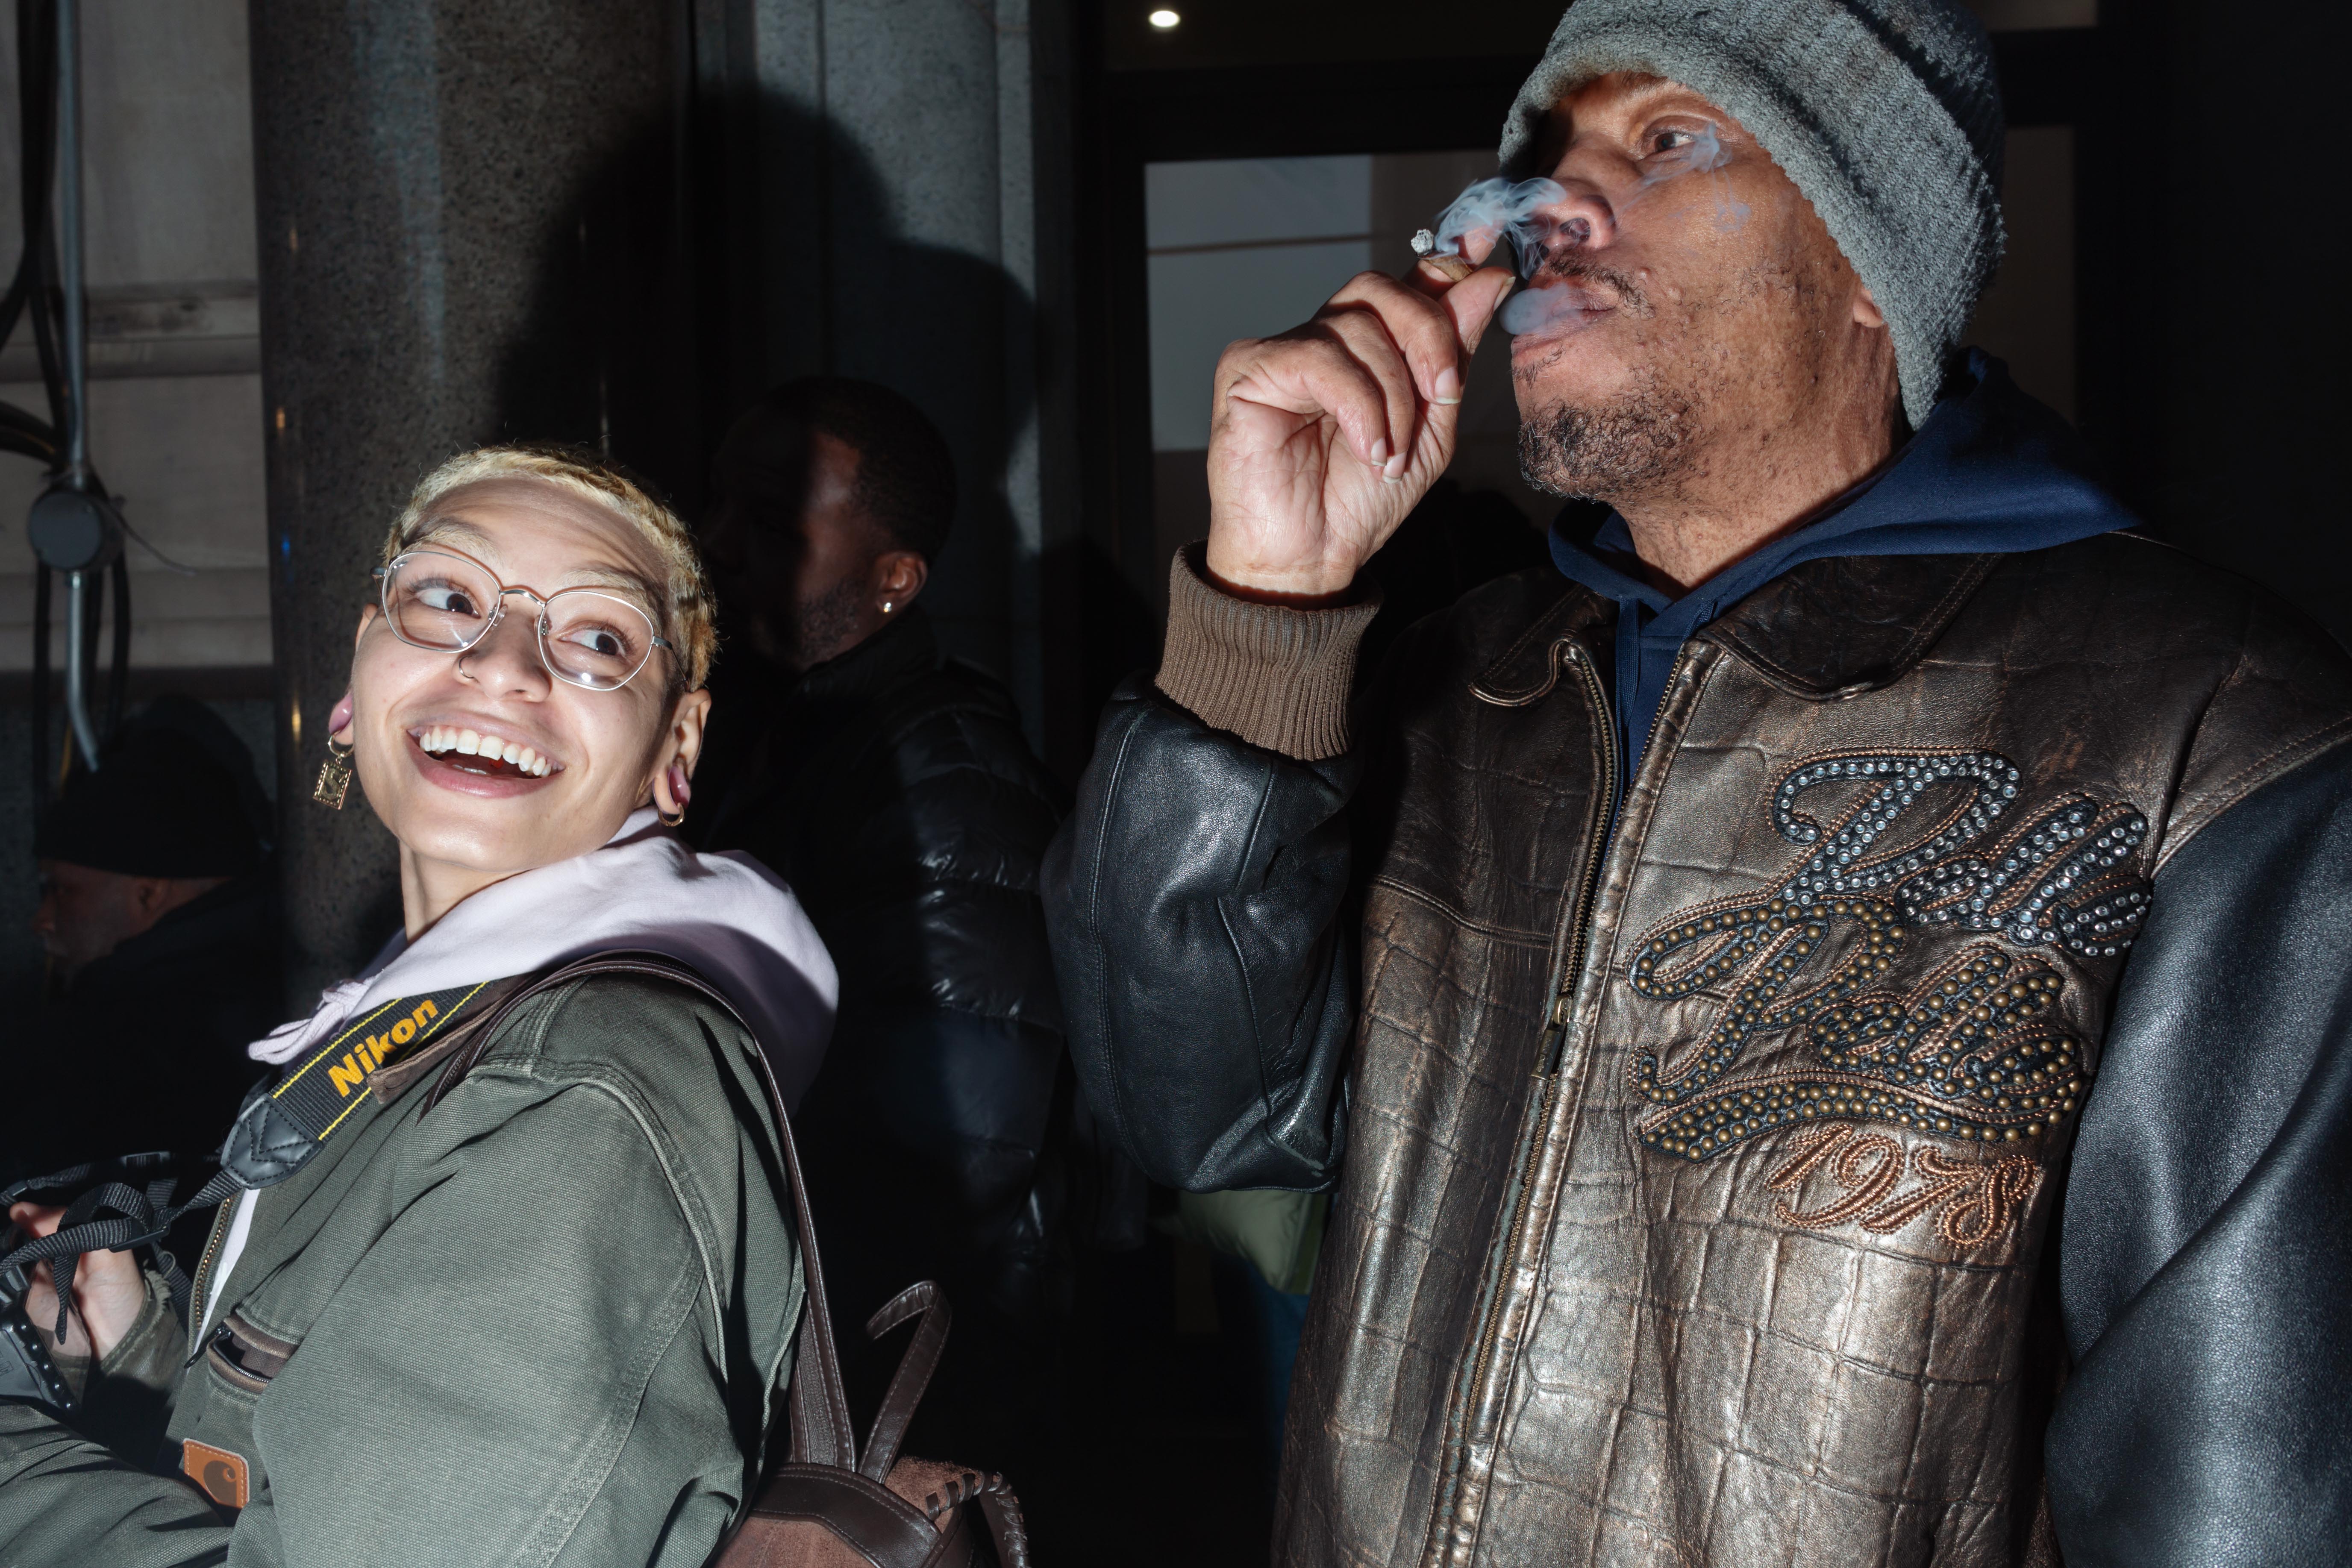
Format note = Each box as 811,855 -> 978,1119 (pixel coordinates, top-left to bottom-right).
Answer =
426,952 -> 861,1476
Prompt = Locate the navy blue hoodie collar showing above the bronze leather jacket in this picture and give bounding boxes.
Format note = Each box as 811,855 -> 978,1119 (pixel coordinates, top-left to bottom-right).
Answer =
1552,348 -> 2138,778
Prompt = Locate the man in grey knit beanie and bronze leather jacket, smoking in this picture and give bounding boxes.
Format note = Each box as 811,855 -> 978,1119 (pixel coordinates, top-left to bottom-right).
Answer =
1047,0 -> 2352,1568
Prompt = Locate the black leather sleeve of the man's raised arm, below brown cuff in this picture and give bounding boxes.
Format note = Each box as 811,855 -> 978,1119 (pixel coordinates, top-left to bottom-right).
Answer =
1044,677 -> 1357,1192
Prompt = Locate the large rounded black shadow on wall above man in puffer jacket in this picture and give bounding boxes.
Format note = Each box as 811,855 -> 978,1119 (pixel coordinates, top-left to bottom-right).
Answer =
496,94 -> 1035,677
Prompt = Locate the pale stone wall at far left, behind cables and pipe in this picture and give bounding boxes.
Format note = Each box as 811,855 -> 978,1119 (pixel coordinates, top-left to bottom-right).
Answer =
0,0 -> 270,672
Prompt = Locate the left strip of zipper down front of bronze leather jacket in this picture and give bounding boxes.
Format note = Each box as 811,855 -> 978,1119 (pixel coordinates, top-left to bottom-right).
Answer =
1423,642 -> 1627,1563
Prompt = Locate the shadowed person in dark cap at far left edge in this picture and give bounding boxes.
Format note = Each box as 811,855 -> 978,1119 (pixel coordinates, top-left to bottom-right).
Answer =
0,696 -> 282,1178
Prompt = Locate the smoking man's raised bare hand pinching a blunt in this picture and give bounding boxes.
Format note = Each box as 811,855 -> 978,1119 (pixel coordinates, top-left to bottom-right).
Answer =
1209,235 -> 1512,599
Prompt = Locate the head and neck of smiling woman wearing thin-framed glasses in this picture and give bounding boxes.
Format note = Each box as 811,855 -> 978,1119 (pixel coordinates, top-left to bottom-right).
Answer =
332,446 -> 715,938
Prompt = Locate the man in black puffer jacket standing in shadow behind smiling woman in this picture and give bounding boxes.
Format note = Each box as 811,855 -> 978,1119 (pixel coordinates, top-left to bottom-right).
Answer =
687,379 -> 1070,1483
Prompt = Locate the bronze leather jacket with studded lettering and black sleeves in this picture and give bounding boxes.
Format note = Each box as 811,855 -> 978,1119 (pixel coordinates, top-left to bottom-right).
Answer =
1047,534 -> 2352,1568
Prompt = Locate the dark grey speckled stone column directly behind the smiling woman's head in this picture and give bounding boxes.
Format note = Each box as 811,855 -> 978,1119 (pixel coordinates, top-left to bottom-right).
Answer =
252,0 -> 701,1008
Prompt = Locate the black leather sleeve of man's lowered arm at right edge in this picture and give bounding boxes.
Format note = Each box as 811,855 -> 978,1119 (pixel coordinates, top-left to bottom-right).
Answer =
2046,748 -> 2352,1568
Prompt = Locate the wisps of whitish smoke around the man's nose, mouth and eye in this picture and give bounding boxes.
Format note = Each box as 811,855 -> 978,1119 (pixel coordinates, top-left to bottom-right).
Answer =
1432,122 -> 1747,336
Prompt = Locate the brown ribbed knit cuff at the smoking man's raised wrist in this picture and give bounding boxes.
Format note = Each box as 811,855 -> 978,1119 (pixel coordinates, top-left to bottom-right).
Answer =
1157,543 -> 1381,762
